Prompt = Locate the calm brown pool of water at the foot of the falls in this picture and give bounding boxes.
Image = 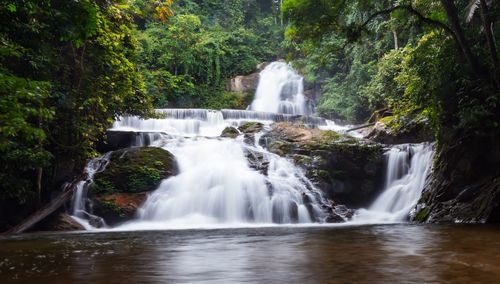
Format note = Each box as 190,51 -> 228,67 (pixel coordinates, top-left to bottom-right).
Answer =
0,225 -> 500,284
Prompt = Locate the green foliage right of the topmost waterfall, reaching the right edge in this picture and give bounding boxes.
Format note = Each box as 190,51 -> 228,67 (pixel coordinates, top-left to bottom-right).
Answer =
283,0 -> 500,133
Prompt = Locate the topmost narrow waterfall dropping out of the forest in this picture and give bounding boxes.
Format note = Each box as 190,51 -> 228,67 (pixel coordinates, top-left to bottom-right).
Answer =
249,61 -> 313,115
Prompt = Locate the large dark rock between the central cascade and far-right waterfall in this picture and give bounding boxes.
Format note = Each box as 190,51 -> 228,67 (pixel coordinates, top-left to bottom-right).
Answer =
259,122 -> 385,208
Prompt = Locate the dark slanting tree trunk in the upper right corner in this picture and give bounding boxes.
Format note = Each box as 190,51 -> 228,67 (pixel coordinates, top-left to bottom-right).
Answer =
441,0 -> 484,77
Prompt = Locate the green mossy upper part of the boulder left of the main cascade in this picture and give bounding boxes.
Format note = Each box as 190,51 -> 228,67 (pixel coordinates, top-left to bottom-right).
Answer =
90,147 -> 177,195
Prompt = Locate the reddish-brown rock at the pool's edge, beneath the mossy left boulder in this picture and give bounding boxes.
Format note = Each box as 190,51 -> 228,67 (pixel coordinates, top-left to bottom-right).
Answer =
93,192 -> 147,226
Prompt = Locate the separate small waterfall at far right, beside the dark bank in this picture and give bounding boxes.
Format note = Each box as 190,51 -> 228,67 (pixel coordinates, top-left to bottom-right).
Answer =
353,143 -> 434,223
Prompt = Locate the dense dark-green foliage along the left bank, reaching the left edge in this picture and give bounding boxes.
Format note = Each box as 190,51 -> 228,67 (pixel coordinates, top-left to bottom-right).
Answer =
0,0 -> 152,202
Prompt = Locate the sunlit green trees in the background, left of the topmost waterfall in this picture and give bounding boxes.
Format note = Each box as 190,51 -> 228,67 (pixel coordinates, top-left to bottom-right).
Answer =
138,0 -> 282,108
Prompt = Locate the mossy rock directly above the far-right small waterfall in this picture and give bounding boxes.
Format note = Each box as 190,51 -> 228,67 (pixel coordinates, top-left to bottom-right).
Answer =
366,116 -> 435,144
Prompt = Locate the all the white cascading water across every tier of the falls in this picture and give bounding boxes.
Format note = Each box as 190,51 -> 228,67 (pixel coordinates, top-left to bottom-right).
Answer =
72,62 -> 432,230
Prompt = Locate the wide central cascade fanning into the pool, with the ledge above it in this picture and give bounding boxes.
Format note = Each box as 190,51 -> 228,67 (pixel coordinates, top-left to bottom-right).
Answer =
115,114 -> 328,229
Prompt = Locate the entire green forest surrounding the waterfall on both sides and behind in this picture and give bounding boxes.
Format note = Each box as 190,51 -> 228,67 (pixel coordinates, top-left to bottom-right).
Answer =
0,0 -> 500,226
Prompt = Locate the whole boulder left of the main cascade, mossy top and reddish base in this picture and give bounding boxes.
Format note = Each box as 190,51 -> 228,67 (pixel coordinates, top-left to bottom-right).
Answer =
89,147 -> 177,225
